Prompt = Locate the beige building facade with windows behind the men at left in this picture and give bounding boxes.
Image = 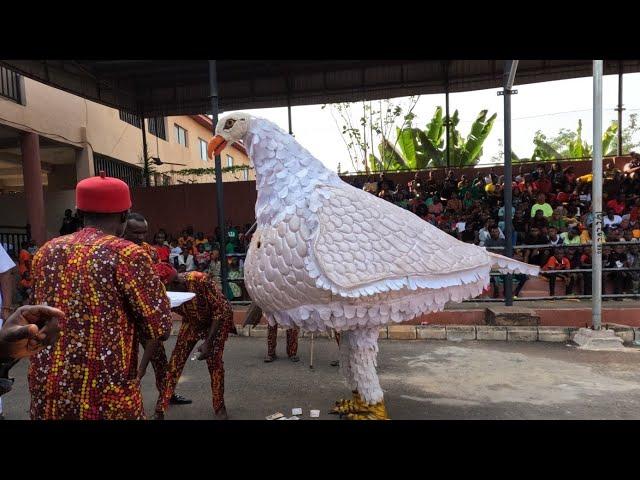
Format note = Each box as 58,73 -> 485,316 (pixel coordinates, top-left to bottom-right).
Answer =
0,67 -> 255,251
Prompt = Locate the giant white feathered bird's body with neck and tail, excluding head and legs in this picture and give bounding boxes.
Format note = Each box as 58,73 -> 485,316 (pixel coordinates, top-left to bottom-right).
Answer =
236,117 -> 538,332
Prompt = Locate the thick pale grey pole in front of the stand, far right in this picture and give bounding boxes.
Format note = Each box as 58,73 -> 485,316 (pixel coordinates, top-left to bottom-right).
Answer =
591,60 -> 603,330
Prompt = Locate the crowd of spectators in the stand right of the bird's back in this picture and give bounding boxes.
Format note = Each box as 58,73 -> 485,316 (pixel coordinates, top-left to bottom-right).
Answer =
350,152 -> 640,296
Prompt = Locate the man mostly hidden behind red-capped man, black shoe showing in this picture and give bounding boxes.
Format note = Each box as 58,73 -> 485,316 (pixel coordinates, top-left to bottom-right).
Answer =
124,212 -> 191,405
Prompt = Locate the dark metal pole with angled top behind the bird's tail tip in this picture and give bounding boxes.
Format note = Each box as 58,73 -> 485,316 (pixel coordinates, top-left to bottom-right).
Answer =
499,60 -> 518,307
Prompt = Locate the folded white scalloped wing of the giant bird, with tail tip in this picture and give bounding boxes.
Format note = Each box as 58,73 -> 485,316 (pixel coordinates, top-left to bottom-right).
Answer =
312,184 -> 537,297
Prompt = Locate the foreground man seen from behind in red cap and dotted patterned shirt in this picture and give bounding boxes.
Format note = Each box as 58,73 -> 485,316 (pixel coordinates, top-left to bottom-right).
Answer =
29,172 -> 171,420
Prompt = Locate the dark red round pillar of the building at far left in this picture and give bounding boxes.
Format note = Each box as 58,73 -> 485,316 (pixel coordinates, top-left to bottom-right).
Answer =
20,132 -> 47,245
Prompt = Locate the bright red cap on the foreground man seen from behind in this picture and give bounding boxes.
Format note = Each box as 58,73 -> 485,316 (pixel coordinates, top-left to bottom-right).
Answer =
76,172 -> 131,213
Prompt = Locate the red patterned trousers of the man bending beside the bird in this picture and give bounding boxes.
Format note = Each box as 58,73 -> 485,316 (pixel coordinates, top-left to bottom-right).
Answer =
156,320 -> 231,413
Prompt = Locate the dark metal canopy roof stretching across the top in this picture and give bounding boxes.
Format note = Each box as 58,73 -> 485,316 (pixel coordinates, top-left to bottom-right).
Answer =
0,60 -> 640,117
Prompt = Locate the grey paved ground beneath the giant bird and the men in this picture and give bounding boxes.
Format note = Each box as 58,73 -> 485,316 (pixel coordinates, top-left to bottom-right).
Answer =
3,337 -> 640,420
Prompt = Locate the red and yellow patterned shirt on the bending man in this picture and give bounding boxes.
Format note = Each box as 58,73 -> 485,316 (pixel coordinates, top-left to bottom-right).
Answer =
178,272 -> 233,338
